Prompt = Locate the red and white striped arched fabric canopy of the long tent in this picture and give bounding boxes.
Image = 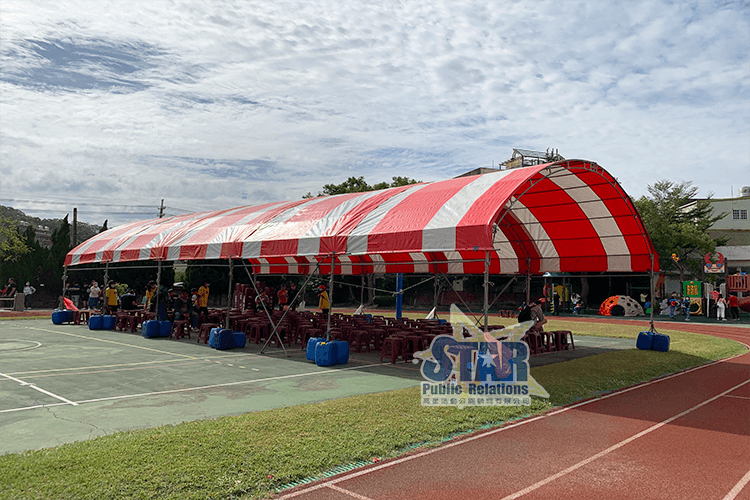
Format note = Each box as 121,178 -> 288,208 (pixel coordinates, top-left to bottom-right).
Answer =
65,160 -> 658,274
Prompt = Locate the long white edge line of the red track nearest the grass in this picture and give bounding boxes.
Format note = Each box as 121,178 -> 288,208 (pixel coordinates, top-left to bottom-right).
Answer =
276,352 -> 748,500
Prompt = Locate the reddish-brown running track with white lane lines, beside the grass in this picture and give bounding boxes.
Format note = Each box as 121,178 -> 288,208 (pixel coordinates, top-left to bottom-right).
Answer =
280,319 -> 750,500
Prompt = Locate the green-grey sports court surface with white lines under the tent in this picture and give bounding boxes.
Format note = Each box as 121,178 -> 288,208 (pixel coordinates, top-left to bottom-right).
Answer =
0,319 -> 634,453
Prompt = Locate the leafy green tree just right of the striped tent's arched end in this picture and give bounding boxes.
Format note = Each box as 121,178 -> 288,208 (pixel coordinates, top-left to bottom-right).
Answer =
635,180 -> 726,280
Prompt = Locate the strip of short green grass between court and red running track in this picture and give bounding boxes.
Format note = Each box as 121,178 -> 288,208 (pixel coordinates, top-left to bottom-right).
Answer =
0,328 -> 745,500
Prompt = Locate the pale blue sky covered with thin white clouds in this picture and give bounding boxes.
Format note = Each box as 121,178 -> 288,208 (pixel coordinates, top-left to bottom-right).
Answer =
0,0 -> 750,227
